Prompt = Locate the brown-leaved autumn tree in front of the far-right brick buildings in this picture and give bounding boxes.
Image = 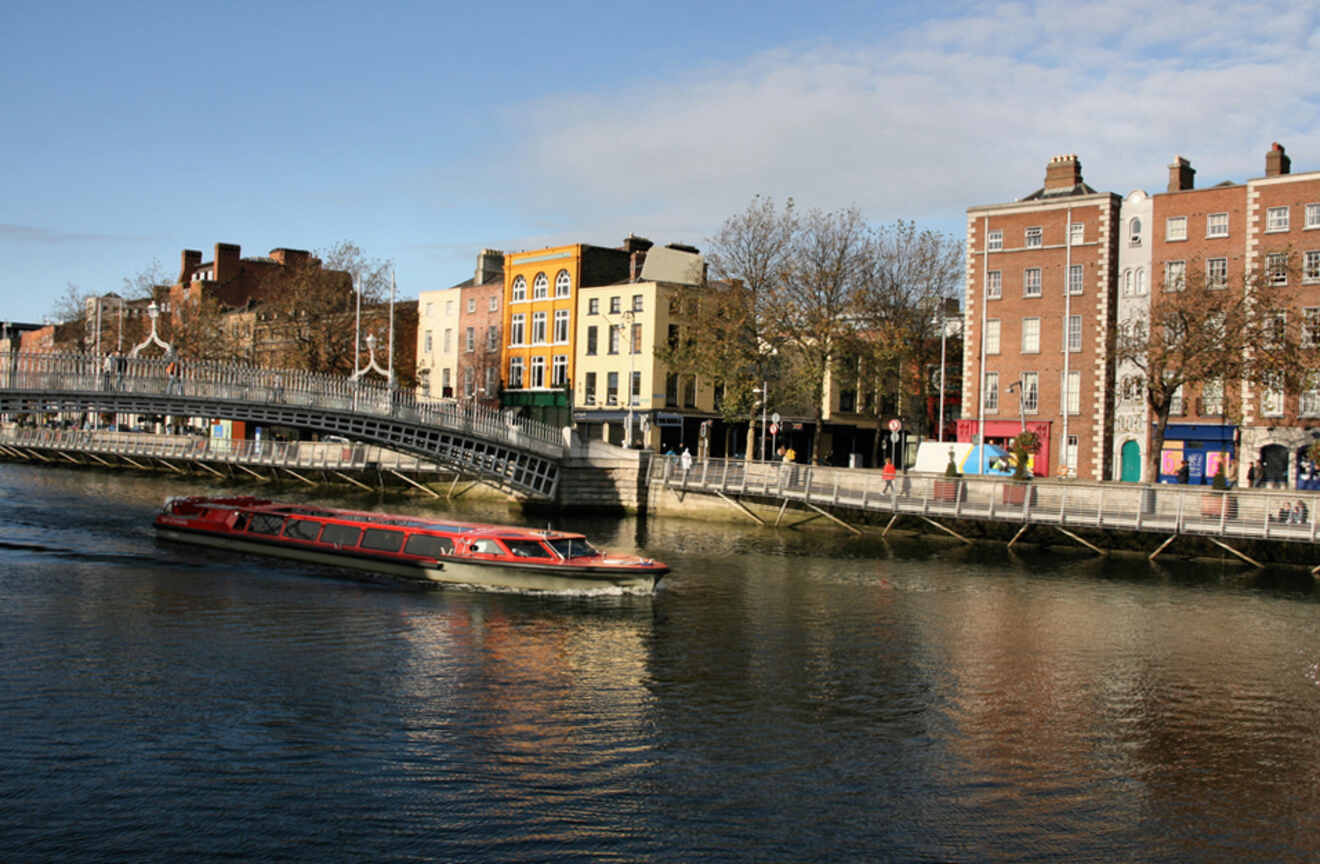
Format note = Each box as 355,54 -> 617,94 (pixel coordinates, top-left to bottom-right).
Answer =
1114,255 -> 1316,478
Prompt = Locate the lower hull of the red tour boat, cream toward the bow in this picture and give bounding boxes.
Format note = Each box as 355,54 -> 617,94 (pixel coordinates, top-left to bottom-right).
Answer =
156,524 -> 663,592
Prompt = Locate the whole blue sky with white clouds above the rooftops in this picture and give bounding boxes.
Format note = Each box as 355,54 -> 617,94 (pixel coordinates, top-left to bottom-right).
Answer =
0,0 -> 1320,322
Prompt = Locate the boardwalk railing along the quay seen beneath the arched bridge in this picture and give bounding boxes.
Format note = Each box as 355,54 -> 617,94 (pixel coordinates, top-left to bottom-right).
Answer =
0,427 -> 491,497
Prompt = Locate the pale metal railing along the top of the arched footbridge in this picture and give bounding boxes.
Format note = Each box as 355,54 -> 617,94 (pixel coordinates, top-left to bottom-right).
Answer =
0,352 -> 564,451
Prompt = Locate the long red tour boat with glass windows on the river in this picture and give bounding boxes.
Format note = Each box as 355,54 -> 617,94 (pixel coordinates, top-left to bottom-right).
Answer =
154,497 -> 669,591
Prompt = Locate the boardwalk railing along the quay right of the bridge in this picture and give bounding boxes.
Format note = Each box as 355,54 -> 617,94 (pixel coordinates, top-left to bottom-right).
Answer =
649,459 -> 1320,570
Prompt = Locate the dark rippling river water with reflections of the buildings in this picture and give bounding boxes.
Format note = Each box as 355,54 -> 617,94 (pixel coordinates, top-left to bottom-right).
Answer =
0,466 -> 1320,861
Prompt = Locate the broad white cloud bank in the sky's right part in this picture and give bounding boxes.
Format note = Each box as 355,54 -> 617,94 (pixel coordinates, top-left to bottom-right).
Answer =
501,0 -> 1320,240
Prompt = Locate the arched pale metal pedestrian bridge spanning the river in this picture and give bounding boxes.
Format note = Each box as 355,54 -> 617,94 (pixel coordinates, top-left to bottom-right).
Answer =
0,352 -> 566,500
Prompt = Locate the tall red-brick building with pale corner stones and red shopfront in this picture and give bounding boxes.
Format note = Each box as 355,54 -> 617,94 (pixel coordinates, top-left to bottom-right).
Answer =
957,156 -> 1121,480
